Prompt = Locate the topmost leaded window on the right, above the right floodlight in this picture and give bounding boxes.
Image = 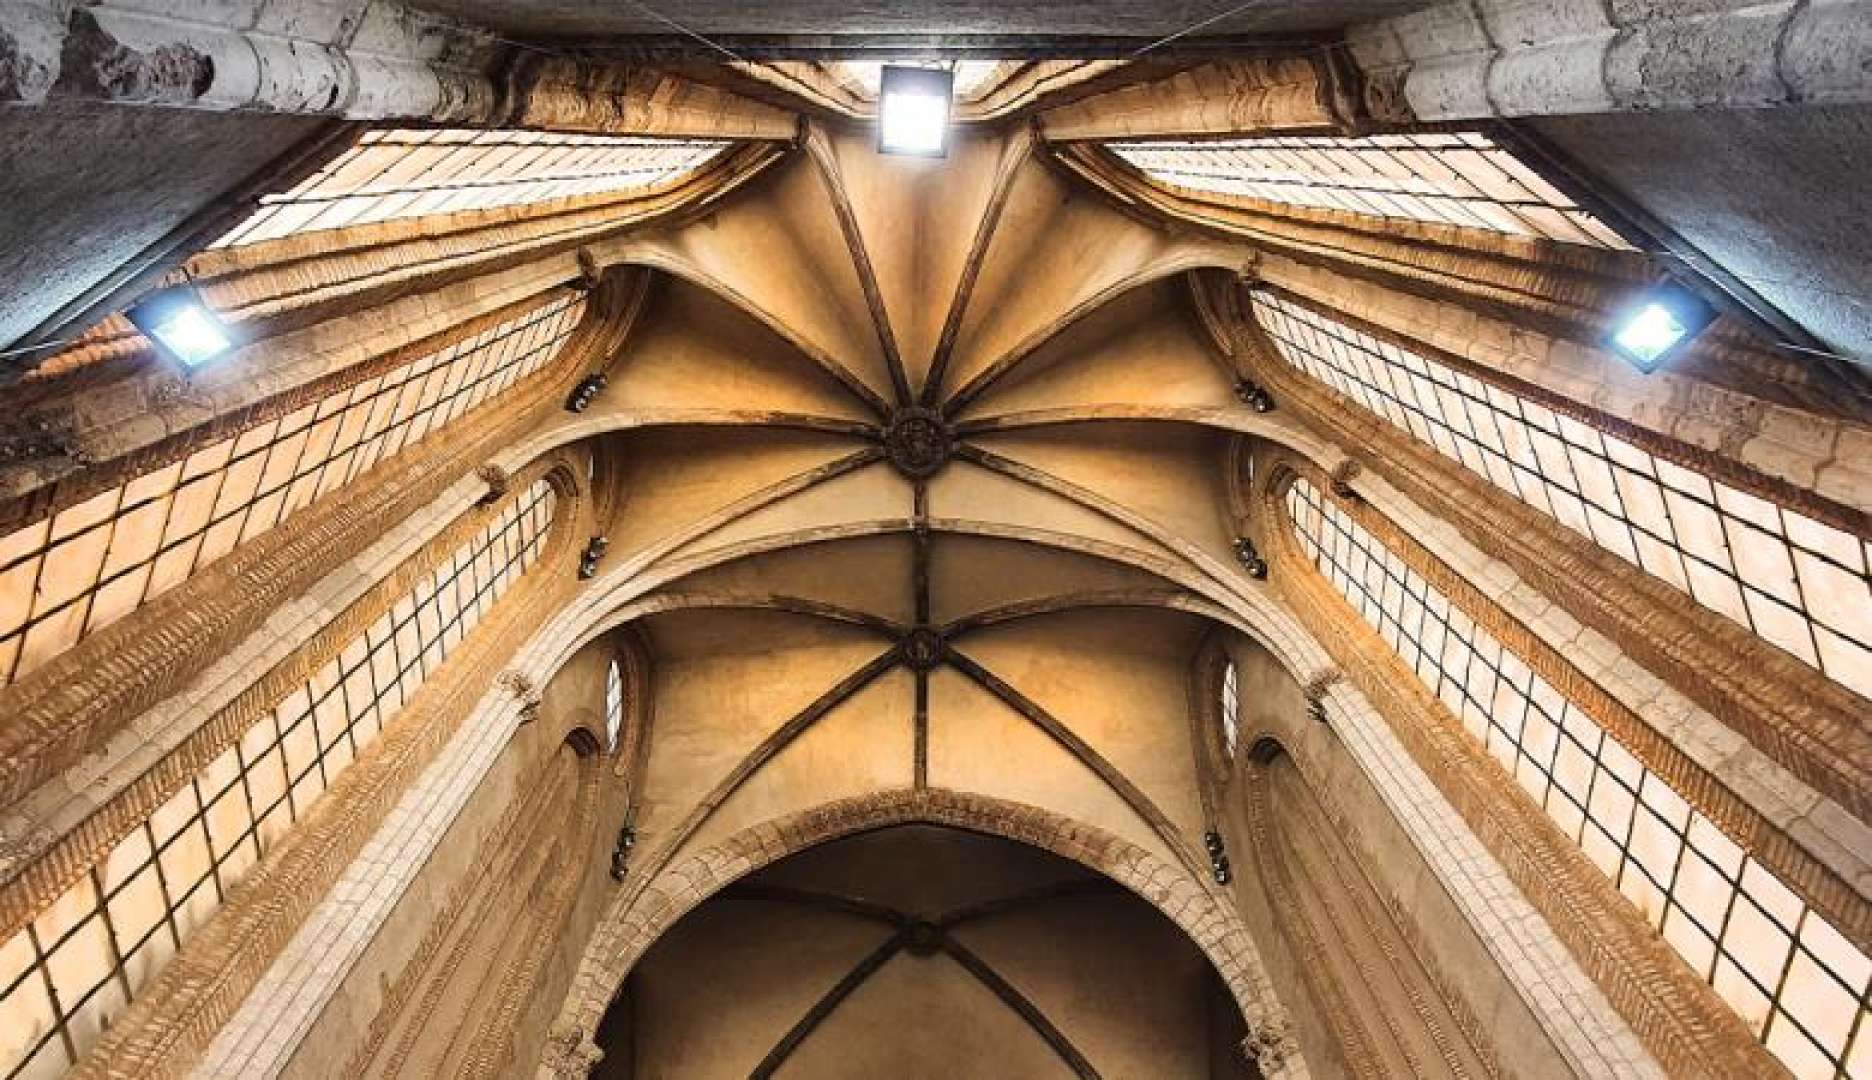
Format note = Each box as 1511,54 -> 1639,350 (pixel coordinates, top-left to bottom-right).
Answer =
1108,131 -> 1632,251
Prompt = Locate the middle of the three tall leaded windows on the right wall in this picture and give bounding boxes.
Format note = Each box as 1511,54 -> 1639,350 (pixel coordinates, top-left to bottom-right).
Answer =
1254,290 -> 1872,694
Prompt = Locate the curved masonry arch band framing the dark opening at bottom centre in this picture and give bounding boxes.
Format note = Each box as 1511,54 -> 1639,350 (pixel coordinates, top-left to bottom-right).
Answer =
537,788 -> 1309,1080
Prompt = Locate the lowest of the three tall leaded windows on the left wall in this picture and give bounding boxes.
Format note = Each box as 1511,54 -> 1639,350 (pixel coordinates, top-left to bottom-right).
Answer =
0,481 -> 554,1080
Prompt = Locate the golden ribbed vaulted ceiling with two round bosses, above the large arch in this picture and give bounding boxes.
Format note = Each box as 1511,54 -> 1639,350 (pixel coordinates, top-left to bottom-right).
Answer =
565,129 -> 1273,870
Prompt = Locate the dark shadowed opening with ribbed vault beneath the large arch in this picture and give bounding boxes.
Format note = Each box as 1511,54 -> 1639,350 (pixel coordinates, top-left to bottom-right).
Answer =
593,824 -> 1258,1080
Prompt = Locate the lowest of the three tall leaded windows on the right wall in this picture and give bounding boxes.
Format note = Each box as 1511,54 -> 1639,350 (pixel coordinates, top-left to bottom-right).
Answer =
1288,481 -> 1872,1078
